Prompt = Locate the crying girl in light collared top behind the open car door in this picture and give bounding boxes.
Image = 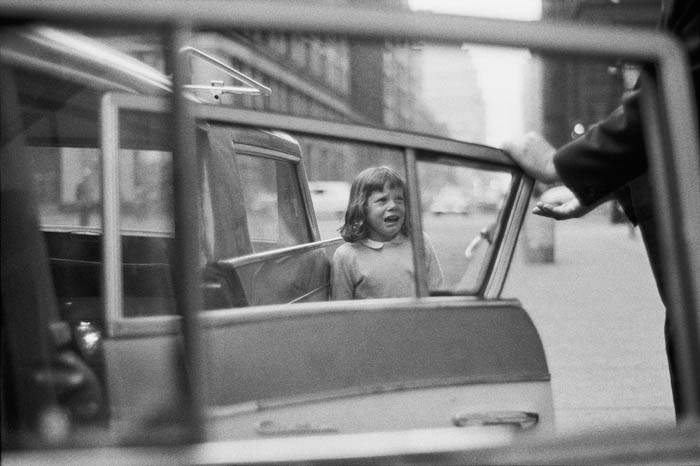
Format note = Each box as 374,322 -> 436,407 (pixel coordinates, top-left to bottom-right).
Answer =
331,167 -> 443,300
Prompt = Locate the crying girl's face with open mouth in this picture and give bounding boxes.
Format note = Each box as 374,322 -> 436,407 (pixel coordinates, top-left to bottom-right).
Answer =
366,183 -> 406,242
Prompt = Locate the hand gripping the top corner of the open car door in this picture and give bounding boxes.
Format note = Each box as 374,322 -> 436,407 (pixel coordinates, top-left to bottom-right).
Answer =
503,132 -> 561,184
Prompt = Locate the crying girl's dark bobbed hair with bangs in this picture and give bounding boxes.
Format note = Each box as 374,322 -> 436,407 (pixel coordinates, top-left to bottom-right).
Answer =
340,167 -> 411,243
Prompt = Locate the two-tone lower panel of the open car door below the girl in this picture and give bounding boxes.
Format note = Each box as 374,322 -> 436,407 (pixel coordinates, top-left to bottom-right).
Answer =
198,298 -> 553,437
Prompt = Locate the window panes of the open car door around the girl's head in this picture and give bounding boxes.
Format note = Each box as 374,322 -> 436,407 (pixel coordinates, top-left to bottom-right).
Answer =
284,134 -> 517,295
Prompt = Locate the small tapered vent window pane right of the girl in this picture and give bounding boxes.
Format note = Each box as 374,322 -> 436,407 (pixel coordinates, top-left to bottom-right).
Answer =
418,162 -> 511,293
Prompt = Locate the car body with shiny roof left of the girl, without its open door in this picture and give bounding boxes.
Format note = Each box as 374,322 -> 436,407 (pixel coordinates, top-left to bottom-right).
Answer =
1,26 -> 338,440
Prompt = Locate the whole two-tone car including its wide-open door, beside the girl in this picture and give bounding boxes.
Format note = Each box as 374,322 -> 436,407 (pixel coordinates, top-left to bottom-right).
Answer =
2,20 -> 554,452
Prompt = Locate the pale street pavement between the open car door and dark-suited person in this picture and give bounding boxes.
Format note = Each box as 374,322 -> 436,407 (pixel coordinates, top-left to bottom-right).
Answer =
503,206 -> 675,433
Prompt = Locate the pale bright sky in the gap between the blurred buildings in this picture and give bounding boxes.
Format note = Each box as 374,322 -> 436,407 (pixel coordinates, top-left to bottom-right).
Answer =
409,0 -> 542,146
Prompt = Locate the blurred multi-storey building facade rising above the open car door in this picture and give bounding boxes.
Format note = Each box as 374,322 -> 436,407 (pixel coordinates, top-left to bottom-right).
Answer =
87,0 -> 483,187
